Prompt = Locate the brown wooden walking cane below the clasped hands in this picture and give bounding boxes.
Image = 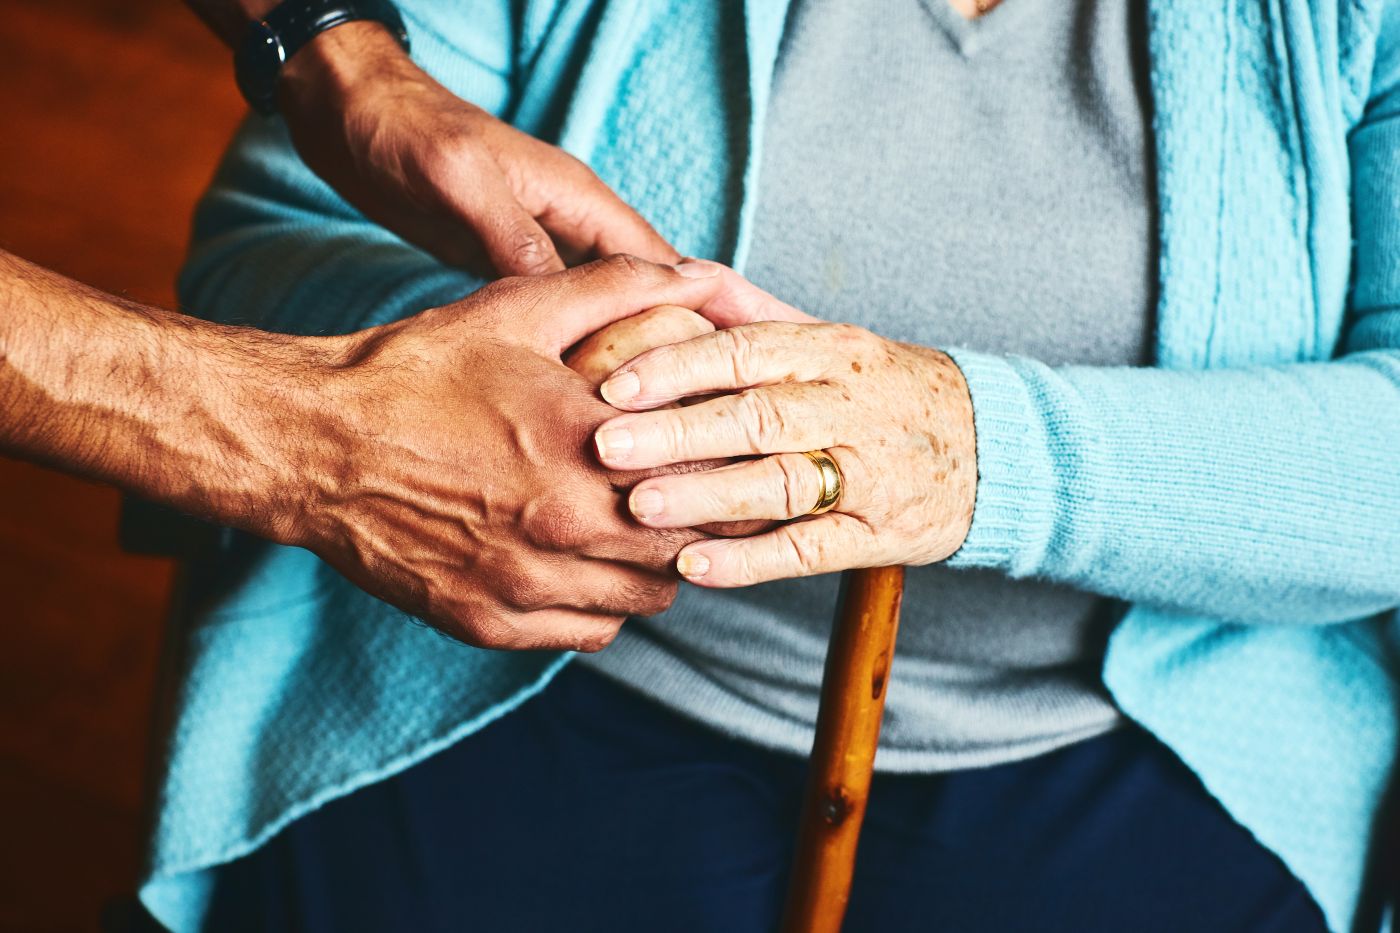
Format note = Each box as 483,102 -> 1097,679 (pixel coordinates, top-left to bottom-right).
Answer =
781,567 -> 904,933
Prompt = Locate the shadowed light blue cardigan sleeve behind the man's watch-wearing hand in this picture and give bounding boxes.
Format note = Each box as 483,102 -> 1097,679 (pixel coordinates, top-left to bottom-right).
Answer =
179,0 -> 526,333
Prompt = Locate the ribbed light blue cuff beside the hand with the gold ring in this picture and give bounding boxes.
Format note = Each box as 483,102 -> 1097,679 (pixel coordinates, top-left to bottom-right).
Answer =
946,349 -> 1054,577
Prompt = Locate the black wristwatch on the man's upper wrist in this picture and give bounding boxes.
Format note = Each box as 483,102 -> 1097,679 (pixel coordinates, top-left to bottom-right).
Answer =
234,0 -> 409,113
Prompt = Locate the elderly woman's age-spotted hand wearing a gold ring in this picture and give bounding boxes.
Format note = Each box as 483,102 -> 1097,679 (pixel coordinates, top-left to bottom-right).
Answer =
595,321 -> 977,587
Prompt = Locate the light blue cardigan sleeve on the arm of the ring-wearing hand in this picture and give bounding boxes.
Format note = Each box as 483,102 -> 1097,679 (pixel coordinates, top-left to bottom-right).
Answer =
949,3 -> 1400,622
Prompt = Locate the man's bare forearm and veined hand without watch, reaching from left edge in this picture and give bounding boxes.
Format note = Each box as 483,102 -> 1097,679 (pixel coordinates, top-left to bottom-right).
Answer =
0,252 -> 725,650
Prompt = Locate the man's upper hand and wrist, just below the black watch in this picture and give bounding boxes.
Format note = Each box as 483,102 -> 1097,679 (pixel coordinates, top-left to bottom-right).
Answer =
279,22 -> 679,277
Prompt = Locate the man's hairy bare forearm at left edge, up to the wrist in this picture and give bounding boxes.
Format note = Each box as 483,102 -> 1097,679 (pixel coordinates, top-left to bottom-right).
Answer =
0,252 -> 340,537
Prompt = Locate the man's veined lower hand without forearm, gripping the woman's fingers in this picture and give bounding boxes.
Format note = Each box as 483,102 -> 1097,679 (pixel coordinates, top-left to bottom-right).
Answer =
265,256 -> 721,650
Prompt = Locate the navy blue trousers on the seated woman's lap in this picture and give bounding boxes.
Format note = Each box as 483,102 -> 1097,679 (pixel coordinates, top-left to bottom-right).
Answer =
210,667 -> 1324,933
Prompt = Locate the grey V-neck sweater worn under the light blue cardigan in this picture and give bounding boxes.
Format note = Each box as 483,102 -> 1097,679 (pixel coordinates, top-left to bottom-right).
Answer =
581,0 -> 1156,772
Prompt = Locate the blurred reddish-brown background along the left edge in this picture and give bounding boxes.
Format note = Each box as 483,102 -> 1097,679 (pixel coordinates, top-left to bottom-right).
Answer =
0,0 -> 242,933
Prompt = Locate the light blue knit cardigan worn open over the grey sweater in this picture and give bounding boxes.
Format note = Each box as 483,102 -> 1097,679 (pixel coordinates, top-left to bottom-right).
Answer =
143,0 -> 1400,933
